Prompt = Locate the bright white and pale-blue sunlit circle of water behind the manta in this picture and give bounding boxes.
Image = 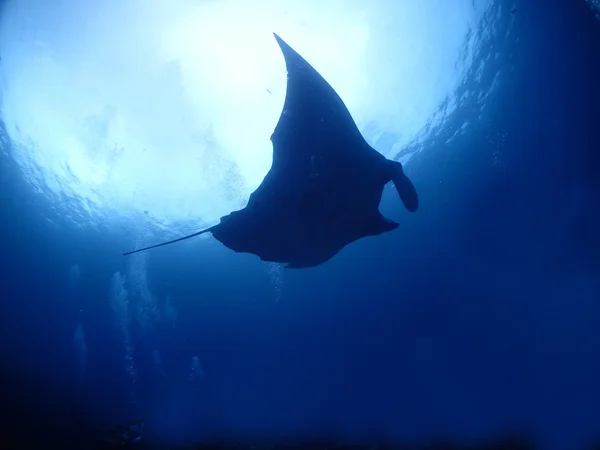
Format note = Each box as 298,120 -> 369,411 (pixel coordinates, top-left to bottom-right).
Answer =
0,0 -> 491,239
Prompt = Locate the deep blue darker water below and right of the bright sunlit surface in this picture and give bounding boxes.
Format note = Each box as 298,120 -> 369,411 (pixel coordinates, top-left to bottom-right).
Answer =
0,0 -> 600,449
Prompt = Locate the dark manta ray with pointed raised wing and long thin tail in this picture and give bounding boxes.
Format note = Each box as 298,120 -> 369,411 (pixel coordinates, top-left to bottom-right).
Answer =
124,34 -> 418,268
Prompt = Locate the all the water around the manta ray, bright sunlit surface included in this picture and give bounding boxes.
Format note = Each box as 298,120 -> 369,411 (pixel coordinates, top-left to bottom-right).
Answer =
0,0 -> 600,449
